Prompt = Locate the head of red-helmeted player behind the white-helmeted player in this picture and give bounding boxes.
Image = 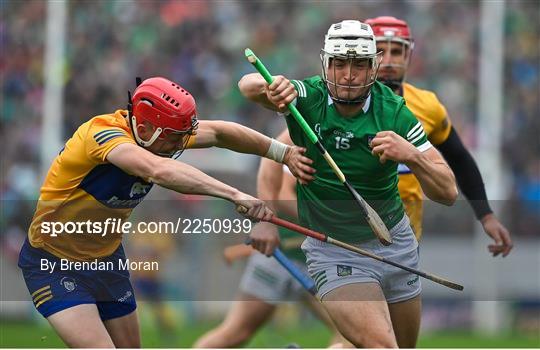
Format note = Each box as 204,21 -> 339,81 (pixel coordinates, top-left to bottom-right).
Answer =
366,16 -> 414,90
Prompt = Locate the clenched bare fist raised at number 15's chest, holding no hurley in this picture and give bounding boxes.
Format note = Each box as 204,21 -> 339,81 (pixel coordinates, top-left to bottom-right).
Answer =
371,131 -> 419,164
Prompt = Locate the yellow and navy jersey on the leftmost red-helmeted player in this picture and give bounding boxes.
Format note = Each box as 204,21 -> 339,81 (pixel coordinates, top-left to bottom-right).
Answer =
28,110 -> 152,261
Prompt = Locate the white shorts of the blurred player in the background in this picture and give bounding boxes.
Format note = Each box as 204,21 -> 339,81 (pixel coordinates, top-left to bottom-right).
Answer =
240,252 -> 307,304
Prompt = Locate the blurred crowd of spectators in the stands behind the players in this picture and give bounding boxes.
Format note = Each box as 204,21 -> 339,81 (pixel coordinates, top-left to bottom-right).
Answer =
0,0 -> 540,243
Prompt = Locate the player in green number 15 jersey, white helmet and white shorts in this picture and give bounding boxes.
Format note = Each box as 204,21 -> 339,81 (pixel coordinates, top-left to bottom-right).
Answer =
238,20 -> 457,348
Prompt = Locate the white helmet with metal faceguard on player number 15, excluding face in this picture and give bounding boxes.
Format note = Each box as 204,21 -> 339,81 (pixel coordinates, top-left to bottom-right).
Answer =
321,20 -> 380,103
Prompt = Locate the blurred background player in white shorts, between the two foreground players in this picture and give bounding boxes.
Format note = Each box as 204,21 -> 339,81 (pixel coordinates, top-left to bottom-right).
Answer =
193,130 -> 344,348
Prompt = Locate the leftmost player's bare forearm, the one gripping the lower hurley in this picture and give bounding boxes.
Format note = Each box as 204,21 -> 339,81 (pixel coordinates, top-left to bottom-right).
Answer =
149,159 -> 239,201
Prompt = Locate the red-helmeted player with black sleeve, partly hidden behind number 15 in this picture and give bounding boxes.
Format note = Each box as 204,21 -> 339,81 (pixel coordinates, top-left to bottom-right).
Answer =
366,16 -> 512,257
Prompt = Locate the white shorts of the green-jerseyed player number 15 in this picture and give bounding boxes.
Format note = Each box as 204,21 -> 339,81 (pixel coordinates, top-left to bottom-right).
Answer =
302,215 -> 422,303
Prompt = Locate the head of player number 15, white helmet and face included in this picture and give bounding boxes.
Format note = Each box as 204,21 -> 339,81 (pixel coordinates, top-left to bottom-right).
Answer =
321,20 -> 380,104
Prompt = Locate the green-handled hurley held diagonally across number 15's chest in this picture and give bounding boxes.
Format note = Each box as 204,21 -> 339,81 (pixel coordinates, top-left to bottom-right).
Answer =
245,49 -> 392,245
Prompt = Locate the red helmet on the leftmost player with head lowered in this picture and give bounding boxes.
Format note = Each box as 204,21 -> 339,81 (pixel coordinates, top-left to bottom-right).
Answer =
130,77 -> 198,147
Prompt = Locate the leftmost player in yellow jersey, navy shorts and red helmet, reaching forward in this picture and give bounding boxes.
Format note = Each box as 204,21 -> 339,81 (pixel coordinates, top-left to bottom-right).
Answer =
19,77 -> 309,348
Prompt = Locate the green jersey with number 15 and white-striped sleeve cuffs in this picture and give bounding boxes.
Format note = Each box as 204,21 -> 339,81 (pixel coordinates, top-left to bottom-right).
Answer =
287,76 -> 431,242
